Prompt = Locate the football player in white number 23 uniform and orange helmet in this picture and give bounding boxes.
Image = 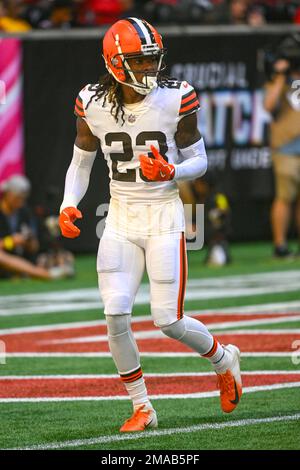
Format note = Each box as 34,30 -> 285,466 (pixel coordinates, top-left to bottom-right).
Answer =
60,18 -> 242,432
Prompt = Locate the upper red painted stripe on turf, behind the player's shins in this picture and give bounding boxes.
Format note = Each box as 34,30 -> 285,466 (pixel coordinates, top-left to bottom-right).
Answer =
0,313 -> 300,353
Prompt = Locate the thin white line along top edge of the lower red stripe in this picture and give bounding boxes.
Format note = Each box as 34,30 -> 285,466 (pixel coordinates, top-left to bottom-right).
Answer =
0,370 -> 300,381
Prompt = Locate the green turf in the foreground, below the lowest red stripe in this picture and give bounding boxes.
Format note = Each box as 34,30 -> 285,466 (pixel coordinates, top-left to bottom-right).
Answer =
1,390 -> 299,450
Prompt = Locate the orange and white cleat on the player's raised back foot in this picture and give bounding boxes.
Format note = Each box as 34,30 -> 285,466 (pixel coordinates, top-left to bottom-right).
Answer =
217,344 -> 242,413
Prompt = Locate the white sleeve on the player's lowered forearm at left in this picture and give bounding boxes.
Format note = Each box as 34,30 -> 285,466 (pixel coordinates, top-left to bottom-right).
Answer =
60,145 -> 97,212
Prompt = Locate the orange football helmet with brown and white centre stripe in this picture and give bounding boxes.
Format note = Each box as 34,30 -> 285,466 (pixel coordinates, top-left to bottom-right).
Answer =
103,18 -> 166,95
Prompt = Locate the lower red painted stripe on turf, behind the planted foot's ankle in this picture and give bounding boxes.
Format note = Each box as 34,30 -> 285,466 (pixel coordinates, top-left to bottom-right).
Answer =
0,372 -> 300,398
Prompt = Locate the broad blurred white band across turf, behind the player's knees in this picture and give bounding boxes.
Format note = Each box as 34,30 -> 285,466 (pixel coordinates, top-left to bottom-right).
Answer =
0,270 -> 300,316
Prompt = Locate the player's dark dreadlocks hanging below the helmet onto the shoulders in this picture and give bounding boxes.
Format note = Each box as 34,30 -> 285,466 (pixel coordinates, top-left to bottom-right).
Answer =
86,73 -> 177,126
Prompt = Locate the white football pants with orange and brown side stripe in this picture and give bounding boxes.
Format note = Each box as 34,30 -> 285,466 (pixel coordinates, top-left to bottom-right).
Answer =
97,227 -> 187,327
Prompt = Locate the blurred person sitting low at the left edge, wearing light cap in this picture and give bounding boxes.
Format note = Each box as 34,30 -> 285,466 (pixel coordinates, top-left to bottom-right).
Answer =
0,175 -> 69,279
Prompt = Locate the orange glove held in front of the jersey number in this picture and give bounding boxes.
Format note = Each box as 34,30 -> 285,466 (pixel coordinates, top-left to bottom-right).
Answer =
139,145 -> 175,181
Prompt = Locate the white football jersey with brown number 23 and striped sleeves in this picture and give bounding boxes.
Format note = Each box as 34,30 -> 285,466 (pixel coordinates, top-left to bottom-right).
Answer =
75,80 -> 199,203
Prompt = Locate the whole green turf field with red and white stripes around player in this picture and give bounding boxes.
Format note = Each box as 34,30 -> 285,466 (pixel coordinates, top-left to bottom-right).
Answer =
0,243 -> 300,450
